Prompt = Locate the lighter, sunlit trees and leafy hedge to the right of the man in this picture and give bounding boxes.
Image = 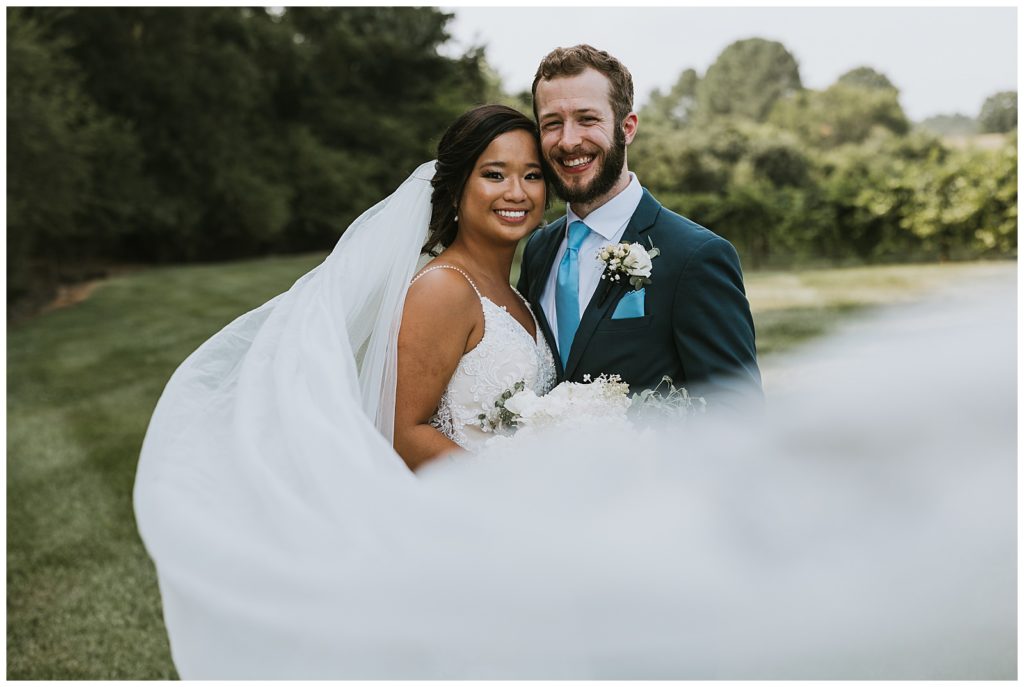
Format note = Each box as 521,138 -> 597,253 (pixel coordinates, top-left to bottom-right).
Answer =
630,39 -> 1017,267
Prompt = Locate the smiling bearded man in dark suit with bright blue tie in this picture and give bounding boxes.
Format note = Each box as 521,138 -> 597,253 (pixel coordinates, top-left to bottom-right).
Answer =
518,45 -> 762,409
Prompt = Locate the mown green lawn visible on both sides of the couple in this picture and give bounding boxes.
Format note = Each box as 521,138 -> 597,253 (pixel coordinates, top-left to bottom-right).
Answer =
7,255 -> 1013,680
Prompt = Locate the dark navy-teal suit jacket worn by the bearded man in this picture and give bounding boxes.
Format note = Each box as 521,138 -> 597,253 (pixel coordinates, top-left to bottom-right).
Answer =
518,188 -> 762,410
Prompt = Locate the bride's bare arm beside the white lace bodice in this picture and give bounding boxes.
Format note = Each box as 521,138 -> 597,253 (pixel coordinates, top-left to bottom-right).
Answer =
394,269 -> 483,470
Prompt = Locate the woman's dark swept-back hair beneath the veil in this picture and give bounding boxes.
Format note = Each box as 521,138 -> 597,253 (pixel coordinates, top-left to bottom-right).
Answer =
422,104 -> 550,255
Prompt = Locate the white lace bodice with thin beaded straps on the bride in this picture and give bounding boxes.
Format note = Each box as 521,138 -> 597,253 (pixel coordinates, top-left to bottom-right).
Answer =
413,265 -> 557,450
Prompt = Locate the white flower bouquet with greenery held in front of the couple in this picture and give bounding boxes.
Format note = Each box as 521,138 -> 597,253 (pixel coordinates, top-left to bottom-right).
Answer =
478,375 -> 706,443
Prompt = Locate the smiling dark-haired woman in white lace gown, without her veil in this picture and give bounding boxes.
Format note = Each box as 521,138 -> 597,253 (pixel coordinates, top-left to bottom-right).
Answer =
394,105 -> 555,469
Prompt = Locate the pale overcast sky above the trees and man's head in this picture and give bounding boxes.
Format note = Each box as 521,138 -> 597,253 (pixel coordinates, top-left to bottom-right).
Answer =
444,7 -> 1017,121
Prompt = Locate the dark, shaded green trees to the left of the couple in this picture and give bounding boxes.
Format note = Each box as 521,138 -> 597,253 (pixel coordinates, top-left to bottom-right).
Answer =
7,7 -> 490,301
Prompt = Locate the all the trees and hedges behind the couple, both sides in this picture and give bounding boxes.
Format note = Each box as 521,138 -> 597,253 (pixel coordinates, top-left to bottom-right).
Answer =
7,7 -> 1017,303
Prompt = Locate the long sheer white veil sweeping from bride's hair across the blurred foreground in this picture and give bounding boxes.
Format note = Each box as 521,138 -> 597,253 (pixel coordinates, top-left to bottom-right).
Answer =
134,165 -> 1017,679
